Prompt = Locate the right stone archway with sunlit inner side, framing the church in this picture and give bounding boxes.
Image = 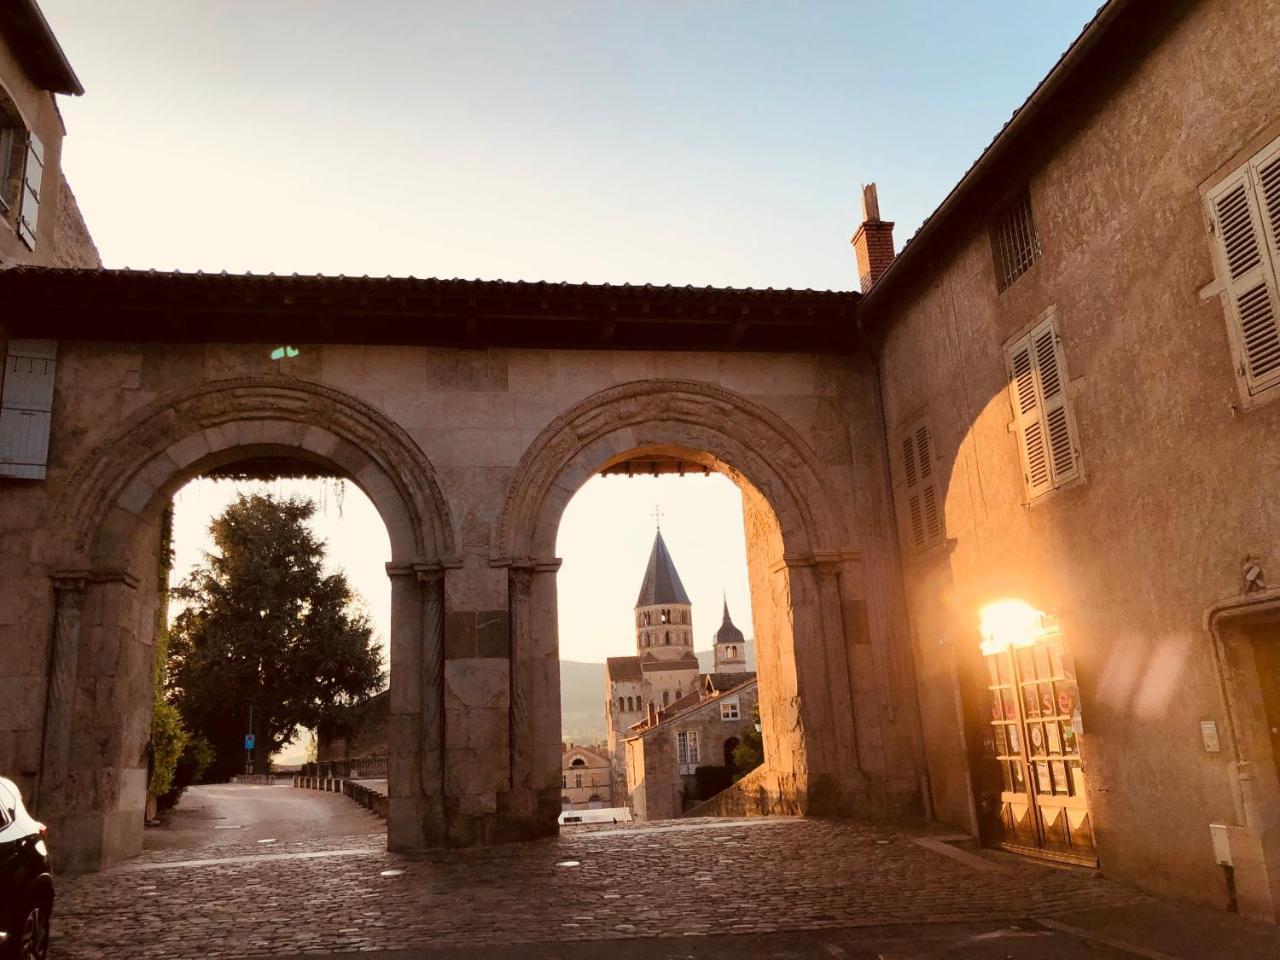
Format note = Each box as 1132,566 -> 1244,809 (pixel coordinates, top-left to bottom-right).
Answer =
493,380 -> 867,820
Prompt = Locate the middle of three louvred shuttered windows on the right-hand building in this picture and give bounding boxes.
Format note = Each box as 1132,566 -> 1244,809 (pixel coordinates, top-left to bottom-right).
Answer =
1005,311 -> 1080,500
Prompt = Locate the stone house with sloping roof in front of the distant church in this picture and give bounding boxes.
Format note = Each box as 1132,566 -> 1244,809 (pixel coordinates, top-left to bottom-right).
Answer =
622,675 -> 758,820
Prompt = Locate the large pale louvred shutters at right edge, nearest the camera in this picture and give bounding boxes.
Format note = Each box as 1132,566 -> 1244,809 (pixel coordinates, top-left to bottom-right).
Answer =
1204,140 -> 1280,397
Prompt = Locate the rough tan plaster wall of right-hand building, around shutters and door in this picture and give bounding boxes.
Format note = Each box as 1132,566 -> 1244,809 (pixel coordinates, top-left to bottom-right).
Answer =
875,0 -> 1280,915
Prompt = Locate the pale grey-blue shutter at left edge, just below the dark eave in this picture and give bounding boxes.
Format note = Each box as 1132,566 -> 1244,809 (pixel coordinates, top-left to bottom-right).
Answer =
0,340 -> 58,480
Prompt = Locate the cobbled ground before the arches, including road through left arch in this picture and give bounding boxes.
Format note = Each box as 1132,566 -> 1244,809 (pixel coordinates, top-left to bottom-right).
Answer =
54,787 -> 1280,960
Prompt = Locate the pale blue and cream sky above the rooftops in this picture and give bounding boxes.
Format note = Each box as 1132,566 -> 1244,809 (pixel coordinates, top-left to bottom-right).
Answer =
42,0 -> 1100,289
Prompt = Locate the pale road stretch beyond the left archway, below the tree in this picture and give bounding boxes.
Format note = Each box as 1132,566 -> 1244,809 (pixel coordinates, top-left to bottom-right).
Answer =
143,783 -> 387,852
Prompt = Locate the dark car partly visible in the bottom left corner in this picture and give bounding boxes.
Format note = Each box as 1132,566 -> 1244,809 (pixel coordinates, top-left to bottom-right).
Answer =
0,777 -> 54,960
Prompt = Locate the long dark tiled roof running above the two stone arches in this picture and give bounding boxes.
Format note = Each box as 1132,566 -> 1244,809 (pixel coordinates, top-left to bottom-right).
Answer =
0,266 -> 859,352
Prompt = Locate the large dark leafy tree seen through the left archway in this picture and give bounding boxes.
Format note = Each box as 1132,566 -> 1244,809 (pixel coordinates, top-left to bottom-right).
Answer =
169,494 -> 385,780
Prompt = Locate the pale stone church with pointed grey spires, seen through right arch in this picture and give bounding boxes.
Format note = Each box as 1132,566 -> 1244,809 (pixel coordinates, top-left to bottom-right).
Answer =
604,530 -> 746,804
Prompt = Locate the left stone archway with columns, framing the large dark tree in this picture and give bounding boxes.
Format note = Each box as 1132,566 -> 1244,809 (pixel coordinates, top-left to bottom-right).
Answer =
37,378 -> 453,870
